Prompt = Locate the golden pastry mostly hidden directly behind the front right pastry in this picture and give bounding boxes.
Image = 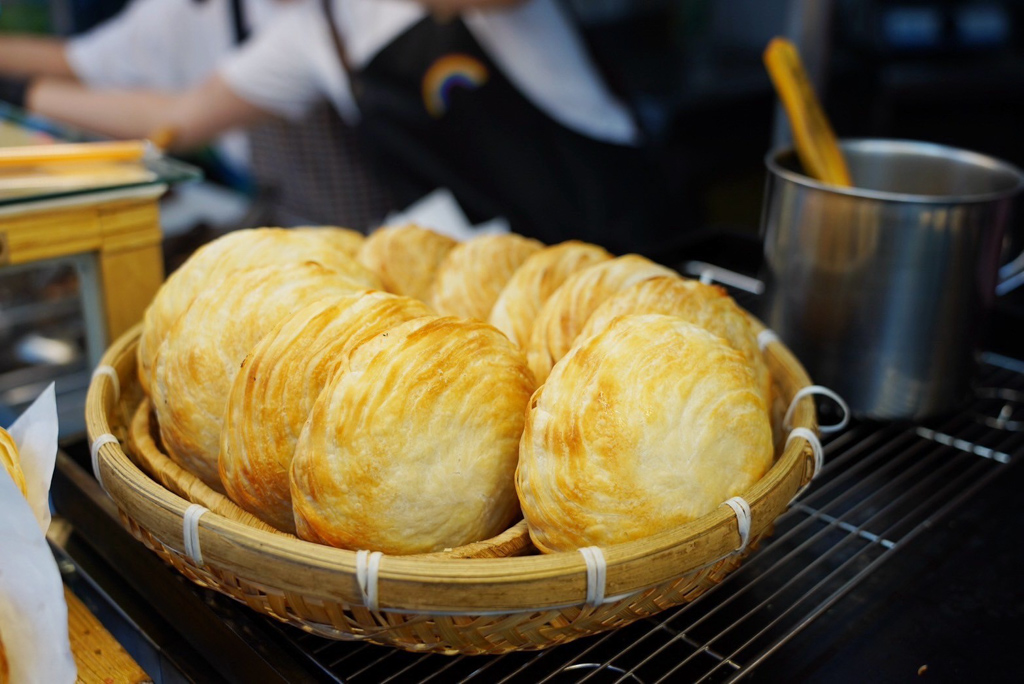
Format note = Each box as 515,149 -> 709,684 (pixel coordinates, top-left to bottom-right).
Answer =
580,277 -> 772,405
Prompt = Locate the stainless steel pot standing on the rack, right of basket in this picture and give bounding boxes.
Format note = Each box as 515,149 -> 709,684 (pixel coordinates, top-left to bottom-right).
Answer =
762,139 -> 1024,419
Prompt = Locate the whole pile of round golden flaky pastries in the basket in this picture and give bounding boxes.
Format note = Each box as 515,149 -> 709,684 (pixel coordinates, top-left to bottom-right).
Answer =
138,225 -> 773,554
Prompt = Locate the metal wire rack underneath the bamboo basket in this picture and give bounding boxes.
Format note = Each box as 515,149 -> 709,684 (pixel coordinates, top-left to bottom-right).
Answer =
262,354 -> 1024,684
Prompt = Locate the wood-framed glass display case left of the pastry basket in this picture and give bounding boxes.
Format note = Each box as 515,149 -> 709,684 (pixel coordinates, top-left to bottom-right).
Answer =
0,104 -> 201,438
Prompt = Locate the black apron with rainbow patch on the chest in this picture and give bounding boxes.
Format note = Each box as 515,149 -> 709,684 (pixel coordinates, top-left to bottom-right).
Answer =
324,0 -> 677,256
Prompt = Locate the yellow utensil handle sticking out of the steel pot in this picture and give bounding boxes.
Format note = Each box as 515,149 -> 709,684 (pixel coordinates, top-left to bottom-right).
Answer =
764,38 -> 853,186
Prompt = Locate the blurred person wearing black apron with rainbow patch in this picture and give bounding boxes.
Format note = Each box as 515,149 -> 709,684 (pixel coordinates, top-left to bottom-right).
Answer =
4,0 -> 681,256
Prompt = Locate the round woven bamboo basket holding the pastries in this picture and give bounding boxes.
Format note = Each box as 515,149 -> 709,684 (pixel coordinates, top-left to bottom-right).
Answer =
86,322 -> 817,654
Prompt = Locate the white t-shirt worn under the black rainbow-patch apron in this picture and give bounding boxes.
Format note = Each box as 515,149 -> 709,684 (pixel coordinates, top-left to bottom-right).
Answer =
220,0 -> 637,144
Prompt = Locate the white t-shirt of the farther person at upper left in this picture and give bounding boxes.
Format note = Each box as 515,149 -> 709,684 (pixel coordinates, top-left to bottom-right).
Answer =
67,0 -> 289,168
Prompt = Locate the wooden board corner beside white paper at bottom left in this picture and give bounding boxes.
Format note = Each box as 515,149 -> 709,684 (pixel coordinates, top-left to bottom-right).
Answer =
65,587 -> 153,684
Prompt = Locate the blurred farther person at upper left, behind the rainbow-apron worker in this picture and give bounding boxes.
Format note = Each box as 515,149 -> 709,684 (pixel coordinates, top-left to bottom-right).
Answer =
0,0 -> 389,230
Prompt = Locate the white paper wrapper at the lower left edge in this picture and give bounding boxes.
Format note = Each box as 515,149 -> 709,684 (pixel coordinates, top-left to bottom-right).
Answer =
0,385 -> 77,684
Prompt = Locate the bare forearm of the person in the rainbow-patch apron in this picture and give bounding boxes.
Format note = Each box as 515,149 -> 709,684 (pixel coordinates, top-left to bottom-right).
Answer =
27,76 -> 271,151
